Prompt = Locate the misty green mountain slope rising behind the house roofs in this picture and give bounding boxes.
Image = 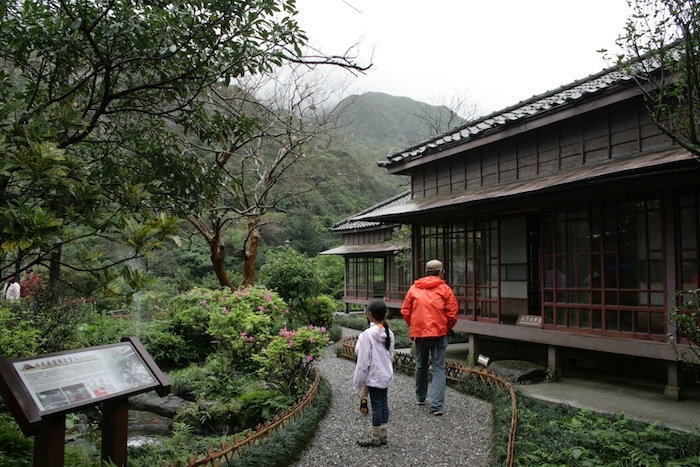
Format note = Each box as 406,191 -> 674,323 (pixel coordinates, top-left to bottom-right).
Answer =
270,92 -> 462,255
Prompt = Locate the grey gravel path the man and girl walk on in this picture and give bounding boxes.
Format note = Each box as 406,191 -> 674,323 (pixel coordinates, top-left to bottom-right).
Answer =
292,330 -> 492,467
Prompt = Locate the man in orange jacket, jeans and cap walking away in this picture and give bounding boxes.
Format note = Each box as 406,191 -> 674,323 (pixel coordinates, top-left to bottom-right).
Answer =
401,259 -> 459,415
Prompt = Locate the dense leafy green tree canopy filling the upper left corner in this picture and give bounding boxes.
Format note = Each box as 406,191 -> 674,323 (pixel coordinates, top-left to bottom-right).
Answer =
0,0 -> 306,288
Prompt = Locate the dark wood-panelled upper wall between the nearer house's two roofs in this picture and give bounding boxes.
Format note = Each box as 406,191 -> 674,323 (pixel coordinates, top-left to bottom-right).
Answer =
411,100 -> 672,198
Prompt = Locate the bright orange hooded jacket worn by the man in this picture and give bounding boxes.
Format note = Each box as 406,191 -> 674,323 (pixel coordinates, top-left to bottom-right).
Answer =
401,276 -> 459,337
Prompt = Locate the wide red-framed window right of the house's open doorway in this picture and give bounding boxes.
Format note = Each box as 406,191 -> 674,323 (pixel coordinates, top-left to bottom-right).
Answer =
541,195 -> 666,340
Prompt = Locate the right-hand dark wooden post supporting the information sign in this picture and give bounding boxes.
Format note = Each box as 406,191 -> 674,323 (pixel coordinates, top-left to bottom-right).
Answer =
102,398 -> 129,467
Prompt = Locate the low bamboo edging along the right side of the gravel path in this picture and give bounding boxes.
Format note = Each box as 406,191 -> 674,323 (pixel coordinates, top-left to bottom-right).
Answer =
340,336 -> 518,467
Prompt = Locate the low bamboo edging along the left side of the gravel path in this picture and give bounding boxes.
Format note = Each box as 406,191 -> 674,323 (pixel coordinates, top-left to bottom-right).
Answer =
169,370 -> 321,467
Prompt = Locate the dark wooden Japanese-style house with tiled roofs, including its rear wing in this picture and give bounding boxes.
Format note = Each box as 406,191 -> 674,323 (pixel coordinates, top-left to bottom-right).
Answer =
324,63 -> 700,398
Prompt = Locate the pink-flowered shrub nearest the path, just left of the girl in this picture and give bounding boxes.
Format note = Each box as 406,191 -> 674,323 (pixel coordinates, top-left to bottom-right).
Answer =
253,325 -> 332,397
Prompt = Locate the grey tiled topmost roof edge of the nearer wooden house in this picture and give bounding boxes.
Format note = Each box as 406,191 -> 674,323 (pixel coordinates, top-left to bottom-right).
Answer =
378,67 -> 631,167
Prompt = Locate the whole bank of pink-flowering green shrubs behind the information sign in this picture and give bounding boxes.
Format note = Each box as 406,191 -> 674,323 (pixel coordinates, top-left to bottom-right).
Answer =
144,287 -> 330,397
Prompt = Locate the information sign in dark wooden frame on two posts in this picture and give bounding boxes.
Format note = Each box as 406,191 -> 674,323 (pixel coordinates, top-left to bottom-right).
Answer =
0,337 -> 170,466
